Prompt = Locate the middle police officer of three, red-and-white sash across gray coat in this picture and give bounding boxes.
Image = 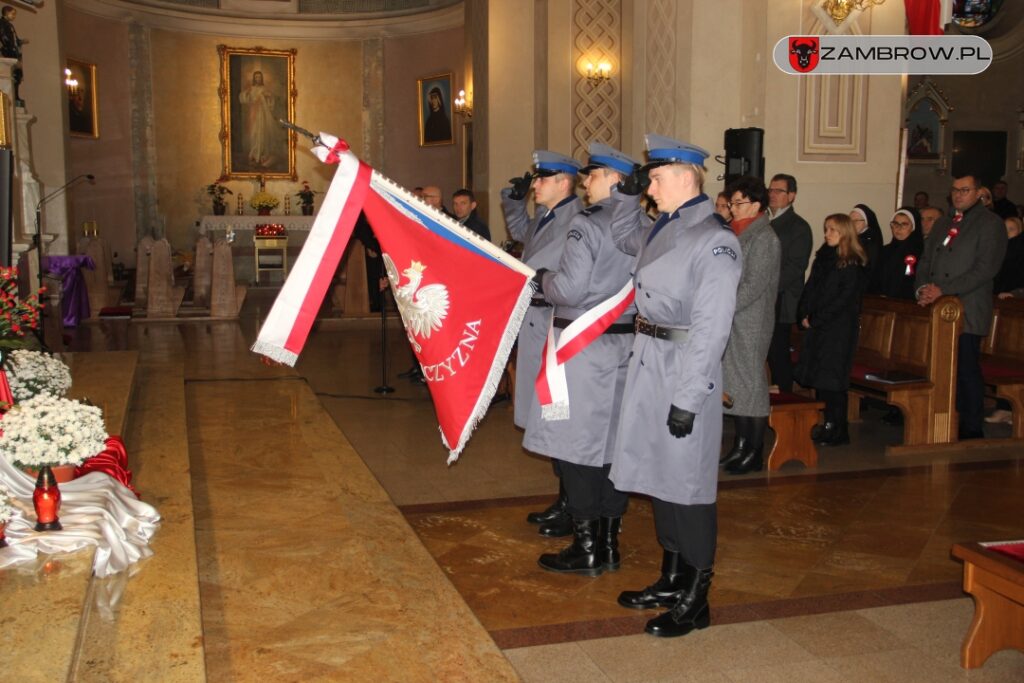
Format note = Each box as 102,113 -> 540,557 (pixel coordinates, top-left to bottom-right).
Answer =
522,142 -> 640,577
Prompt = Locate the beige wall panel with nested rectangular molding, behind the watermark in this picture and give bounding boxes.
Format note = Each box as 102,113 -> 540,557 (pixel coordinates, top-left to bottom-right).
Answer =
797,0 -> 870,162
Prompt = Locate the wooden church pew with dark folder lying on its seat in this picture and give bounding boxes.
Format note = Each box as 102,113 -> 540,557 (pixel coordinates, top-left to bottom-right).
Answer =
848,296 -> 964,454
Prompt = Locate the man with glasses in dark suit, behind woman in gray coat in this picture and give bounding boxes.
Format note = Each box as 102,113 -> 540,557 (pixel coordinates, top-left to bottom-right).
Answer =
768,173 -> 814,391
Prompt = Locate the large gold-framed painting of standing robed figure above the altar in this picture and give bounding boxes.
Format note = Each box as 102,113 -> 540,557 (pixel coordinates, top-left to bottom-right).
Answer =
217,45 -> 298,180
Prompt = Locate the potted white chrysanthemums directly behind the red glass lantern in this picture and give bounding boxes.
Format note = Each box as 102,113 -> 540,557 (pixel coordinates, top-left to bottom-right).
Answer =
0,393 -> 106,469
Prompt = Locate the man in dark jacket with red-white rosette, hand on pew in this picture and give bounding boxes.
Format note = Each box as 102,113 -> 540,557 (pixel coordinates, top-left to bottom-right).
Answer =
914,175 -> 1008,439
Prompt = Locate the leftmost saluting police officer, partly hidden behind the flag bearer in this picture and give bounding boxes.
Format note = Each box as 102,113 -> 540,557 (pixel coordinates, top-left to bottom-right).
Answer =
502,150 -> 583,537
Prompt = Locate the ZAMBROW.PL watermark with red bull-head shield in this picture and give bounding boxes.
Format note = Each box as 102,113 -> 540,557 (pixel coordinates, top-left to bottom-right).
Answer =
772,36 -> 992,75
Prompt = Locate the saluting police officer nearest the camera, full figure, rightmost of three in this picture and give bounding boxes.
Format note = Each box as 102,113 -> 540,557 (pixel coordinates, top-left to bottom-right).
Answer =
610,134 -> 742,637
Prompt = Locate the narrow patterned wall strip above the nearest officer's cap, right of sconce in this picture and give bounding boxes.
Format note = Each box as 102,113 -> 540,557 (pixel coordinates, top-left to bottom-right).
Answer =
644,0 -> 676,135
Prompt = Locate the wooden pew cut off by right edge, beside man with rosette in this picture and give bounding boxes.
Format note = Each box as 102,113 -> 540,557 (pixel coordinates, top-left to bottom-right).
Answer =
981,299 -> 1024,439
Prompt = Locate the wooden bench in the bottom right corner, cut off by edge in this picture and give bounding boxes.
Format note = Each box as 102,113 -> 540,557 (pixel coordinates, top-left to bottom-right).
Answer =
952,541 -> 1024,669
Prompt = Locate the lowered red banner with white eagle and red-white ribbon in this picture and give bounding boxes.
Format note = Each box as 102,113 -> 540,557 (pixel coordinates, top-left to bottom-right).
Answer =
252,133 -> 534,463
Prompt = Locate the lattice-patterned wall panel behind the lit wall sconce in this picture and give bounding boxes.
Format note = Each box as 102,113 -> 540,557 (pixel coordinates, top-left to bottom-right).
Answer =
572,0 -> 623,161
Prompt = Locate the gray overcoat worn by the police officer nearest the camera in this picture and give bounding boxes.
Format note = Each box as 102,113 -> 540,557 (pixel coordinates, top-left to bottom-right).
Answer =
610,191 -> 742,505
